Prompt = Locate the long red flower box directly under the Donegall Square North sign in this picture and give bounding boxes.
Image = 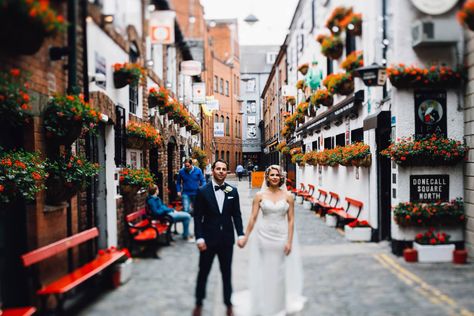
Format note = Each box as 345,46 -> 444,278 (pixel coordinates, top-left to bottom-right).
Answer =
393,198 -> 466,226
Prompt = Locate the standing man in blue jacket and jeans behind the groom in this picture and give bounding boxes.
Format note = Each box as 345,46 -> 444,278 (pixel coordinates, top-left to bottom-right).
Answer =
176,159 -> 206,213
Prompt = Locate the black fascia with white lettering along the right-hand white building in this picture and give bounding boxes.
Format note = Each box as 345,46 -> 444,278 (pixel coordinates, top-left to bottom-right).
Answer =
296,90 -> 364,135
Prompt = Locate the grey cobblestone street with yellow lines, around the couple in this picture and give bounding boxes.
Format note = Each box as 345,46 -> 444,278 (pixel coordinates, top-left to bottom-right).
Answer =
78,179 -> 474,316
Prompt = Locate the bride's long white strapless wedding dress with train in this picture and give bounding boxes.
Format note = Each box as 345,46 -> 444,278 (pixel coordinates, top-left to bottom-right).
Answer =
233,199 -> 306,316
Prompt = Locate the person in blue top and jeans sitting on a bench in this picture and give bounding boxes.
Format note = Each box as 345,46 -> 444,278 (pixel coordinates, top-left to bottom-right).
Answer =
146,185 -> 194,242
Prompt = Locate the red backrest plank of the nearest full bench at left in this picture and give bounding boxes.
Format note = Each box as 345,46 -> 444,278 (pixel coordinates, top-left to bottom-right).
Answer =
21,227 -> 99,267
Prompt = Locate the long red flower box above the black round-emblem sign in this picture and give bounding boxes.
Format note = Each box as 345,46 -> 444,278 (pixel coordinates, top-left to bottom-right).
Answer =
387,64 -> 463,89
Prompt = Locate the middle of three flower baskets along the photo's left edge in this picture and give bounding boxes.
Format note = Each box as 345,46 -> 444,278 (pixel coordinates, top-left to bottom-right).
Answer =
0,68 -> 31,125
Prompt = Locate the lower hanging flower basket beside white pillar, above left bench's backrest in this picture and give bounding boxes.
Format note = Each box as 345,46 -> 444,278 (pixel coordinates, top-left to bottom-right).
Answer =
46,152 -> 99,205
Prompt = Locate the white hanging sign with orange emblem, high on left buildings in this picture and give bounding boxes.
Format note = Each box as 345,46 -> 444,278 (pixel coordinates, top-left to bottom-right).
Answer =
149,11 -> 176,45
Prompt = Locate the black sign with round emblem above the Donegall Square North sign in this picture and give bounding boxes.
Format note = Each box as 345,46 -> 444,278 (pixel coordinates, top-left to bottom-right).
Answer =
415,90 -> 448,138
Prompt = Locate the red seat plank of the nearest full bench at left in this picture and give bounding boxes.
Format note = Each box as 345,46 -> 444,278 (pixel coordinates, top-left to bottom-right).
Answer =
37,250 -> 125,295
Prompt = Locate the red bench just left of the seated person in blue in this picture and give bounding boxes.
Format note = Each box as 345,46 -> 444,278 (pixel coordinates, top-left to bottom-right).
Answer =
125,208 -> 173,253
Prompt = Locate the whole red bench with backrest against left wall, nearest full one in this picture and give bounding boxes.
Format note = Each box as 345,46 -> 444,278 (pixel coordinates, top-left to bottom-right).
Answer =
21,227 -> 125,315
